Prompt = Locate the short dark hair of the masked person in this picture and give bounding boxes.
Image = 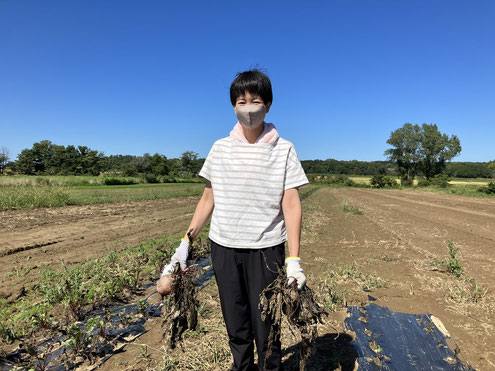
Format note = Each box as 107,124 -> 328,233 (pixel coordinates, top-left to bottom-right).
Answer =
230,68 -> 273,106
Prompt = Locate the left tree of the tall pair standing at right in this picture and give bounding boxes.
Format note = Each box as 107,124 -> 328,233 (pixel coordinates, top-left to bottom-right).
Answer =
385,123 -> 421,181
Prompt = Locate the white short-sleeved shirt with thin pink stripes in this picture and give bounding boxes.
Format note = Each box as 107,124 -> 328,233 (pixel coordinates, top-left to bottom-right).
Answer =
199,136 -> 309,249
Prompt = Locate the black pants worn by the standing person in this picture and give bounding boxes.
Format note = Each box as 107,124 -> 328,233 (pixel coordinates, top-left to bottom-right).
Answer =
210,240 -> 285,370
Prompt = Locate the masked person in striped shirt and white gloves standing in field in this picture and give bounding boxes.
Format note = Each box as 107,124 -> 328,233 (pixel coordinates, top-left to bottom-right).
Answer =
157,69 -> 308,370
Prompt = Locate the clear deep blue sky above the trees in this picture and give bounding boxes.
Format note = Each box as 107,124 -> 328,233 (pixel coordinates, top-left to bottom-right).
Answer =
0,0 -> 495,161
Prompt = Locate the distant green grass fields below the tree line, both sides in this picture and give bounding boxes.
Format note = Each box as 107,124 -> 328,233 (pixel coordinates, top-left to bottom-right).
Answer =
0,176 -> 493,211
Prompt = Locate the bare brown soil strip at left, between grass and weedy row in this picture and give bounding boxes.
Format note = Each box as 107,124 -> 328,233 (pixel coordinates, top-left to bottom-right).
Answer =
0,196 -> 199,297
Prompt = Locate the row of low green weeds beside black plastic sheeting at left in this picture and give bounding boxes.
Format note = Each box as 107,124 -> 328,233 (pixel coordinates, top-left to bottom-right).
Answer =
0,226 -> 208,343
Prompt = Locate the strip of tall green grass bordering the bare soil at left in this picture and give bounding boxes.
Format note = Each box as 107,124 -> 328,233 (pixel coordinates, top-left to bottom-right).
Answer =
0,183 -> 204,211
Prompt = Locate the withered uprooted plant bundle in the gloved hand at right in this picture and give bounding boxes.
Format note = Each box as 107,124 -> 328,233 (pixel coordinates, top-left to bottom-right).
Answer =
258,268 -> 328,370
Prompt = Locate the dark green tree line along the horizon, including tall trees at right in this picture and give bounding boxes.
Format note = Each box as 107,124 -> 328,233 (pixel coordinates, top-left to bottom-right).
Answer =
0,123 -> 495,182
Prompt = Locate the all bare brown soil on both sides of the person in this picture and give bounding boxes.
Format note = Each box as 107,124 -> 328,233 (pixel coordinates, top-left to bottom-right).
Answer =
0,187 -> 495,370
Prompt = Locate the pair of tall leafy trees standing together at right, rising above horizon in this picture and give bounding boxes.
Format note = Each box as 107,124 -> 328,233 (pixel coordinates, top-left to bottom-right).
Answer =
385,123 -> 461,181
